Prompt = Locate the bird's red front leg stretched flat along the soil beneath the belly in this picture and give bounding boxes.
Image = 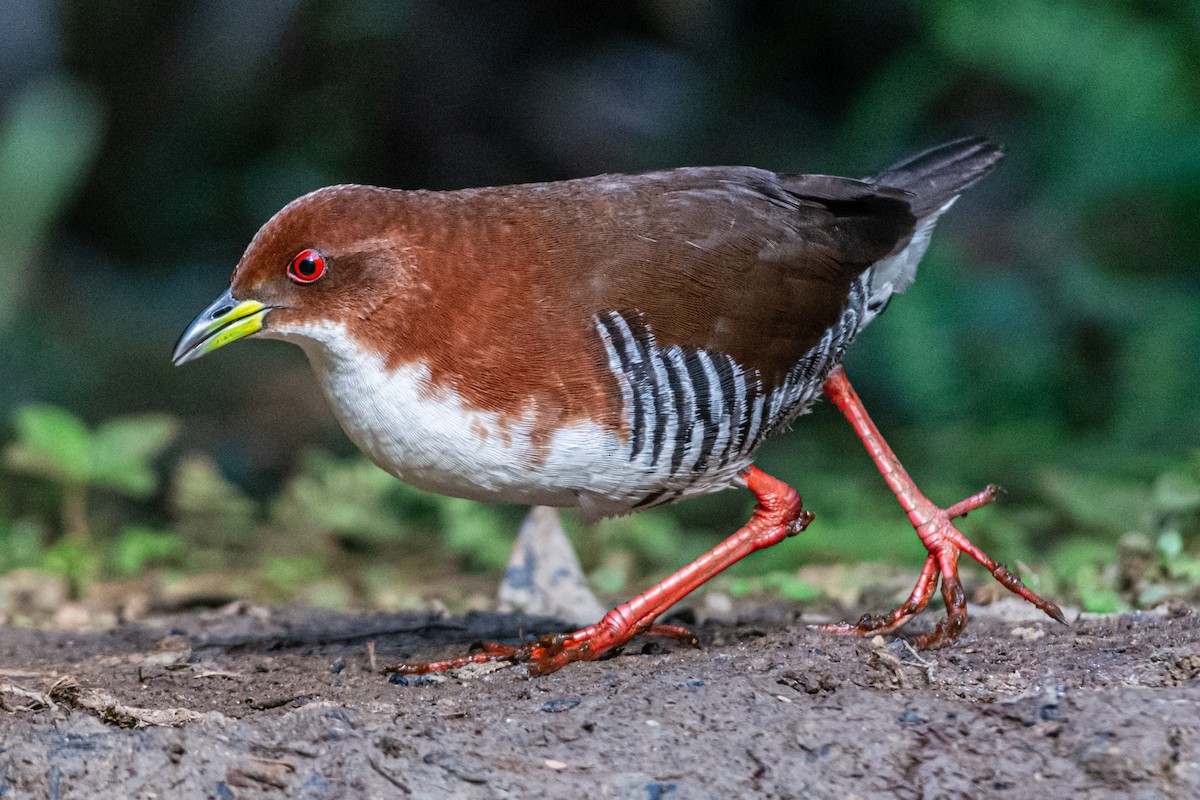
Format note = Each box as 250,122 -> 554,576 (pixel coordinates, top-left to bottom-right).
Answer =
383,467 -> 812,675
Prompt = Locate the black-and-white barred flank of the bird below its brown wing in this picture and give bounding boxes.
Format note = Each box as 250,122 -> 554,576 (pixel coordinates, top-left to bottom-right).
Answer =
594,275 -> 877,509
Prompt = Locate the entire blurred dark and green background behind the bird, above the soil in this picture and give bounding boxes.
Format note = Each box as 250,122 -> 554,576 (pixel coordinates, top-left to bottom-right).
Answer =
0,0 -> 1200,609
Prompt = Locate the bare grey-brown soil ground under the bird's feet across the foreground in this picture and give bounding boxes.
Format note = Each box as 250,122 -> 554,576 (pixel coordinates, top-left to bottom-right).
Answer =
0,601 -> 1200,800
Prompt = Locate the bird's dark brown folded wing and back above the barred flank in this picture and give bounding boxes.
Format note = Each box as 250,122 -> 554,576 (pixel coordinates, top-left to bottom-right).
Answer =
535,167 -> 916,389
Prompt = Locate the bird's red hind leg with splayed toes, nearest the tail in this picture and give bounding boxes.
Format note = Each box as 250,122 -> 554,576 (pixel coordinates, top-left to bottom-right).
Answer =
821,366 -> 1066,648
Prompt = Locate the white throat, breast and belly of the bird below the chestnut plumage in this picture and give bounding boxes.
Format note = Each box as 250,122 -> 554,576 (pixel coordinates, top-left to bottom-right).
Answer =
270,323 -> 734,518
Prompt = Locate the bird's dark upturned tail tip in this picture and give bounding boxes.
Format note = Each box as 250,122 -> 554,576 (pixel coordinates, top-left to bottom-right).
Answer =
866,137 -> 1004,219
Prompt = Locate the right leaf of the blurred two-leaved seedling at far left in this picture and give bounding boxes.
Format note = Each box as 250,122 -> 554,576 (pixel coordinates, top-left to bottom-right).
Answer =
89,414 -> 179,498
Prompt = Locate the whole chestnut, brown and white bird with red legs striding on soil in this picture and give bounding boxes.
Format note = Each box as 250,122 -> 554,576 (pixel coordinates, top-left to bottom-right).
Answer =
173,137 -> 1064,674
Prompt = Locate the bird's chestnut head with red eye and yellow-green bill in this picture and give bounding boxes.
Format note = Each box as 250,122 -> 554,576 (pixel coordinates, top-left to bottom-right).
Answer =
172,186 -> 408,365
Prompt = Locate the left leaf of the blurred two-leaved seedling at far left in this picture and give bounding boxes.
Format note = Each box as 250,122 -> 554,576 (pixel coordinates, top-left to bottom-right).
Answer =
5,405 -> 91,483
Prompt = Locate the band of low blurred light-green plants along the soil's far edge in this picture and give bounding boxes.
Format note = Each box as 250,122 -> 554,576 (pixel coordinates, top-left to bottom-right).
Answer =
0,405 -> 1200,612
